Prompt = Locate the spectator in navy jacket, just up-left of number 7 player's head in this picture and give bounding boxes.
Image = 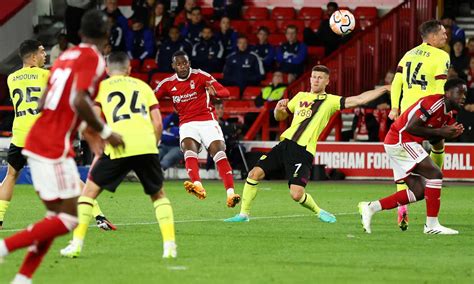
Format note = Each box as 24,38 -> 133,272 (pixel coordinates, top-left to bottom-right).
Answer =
276,25 -> 308,75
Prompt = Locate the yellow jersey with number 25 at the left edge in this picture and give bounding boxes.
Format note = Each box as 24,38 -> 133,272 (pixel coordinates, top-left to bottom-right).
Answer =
7,67 -> 49,147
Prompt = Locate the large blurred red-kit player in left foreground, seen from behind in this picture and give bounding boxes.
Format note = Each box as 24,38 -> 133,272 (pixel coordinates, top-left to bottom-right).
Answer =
0,10 -> 123,283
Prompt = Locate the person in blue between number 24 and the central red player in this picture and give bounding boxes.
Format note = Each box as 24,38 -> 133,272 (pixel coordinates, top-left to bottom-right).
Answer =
158,112 -> 184,171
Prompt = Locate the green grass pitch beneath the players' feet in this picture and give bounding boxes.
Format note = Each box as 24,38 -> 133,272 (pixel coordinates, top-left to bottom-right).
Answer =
0,181 -> 474,284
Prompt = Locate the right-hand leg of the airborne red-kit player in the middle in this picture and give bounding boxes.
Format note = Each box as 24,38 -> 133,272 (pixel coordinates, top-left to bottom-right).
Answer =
207,140 -> 240,207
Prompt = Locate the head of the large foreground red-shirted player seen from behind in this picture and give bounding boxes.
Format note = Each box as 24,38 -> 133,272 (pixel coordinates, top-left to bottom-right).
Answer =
79,10 -> 109,51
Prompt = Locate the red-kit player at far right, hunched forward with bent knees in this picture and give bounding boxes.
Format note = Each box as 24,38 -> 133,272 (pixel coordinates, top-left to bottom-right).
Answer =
359,78 -> 467,235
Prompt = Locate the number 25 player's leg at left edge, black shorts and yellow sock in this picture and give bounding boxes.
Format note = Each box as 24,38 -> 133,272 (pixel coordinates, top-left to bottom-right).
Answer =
0,144 -> 26,230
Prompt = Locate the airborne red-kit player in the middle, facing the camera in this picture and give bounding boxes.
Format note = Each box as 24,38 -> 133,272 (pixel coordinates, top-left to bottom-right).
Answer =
155,51 -> 240,207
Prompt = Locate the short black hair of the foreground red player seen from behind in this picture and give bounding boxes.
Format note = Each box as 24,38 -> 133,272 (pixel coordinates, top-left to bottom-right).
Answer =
80,10 -> 109,39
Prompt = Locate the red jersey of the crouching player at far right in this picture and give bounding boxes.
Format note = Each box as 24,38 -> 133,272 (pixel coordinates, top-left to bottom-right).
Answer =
384,95 -> 456,145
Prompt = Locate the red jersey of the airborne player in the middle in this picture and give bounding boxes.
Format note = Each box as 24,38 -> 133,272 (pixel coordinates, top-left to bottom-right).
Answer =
155,69 -> 229,125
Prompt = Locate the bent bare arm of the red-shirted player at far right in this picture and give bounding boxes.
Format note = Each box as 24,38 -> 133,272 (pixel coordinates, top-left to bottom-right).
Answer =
406,115 -> 464,139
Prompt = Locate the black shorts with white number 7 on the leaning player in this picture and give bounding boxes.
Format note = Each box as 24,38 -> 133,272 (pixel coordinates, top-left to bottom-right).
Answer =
256,139 -> 314,187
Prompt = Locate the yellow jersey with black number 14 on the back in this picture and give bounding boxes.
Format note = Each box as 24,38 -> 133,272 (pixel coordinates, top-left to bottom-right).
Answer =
391,43 -> 450,113
